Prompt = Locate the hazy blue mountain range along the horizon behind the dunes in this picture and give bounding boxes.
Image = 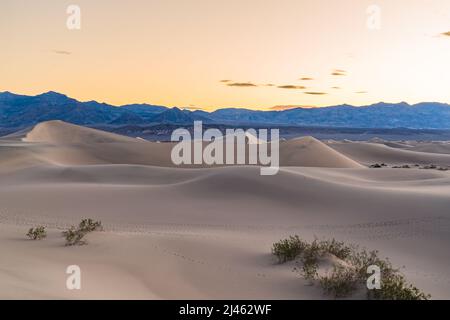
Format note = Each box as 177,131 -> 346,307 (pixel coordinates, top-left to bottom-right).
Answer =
0,91 -> 450,129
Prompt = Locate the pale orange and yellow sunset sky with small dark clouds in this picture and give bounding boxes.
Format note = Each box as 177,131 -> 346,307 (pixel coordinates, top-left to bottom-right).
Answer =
0,0 -> 450,110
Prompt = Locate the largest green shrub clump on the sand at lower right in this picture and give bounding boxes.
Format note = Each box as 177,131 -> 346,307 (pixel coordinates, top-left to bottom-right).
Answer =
272,236 -> 431,300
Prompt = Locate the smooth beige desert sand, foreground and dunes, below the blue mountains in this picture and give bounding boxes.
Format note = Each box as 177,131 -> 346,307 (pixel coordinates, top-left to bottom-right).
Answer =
0,121 -> 450,299
